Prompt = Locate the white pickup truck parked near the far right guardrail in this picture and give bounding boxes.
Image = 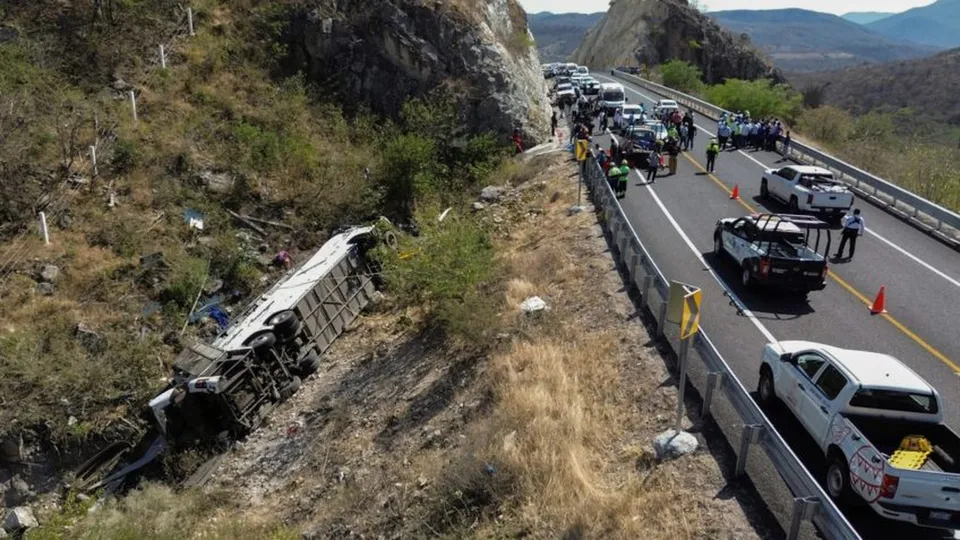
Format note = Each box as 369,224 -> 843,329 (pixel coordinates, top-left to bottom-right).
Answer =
760,165 -> 853,214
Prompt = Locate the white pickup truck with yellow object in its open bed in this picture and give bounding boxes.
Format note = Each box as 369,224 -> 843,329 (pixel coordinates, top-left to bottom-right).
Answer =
758,341 -> 960,529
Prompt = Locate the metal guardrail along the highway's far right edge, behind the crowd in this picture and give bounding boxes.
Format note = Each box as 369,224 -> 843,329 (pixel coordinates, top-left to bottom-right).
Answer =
616,71 -> 960,245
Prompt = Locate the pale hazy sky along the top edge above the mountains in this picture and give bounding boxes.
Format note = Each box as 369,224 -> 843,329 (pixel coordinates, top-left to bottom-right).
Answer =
520,0 -> 933,15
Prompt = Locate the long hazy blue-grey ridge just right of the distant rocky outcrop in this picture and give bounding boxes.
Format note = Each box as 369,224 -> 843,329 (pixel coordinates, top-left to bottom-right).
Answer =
709,9 -> 938,71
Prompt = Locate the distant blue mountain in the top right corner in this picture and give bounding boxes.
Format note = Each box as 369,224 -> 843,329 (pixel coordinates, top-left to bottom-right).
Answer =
867,0 -> 960,48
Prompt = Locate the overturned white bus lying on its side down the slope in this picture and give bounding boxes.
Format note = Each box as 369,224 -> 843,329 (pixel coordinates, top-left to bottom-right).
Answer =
70,227 -> 397,492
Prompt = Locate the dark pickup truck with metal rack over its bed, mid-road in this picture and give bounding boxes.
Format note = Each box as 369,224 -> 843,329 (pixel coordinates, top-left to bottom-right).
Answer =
713,214 -> 832,294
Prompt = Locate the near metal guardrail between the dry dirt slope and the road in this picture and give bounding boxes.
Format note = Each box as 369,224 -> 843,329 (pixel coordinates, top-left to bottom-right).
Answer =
584,157 -> 860,539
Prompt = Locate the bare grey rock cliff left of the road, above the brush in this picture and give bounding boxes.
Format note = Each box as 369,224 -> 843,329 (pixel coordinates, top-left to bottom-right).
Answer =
286,0 -> 550,144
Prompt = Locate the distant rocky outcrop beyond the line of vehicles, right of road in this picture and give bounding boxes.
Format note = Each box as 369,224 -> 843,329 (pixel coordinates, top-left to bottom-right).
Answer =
573,0 -> 782,83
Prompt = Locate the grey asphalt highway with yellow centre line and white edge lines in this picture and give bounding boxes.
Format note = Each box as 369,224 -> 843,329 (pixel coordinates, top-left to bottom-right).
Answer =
594,74 -> 960,538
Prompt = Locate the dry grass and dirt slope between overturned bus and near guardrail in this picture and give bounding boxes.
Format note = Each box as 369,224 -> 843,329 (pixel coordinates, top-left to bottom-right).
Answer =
201,153 -> 765,538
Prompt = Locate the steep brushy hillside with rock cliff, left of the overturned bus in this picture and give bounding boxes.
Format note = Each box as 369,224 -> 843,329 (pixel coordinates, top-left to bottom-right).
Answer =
0,0 -> 549,484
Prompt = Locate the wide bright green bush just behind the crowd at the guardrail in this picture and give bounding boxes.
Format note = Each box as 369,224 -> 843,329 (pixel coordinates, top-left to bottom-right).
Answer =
705,79 -> 803,120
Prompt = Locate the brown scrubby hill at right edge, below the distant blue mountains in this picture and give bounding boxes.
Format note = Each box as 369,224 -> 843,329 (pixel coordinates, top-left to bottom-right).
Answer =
789,49 -> 960,125
